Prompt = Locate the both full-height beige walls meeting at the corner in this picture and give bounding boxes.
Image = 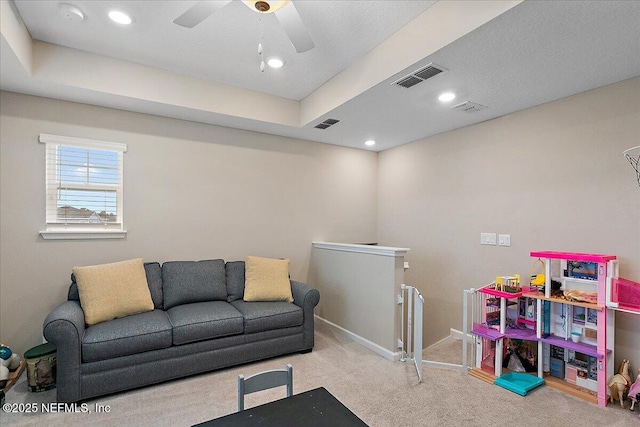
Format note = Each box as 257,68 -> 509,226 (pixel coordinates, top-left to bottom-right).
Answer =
0,79 -> 640,359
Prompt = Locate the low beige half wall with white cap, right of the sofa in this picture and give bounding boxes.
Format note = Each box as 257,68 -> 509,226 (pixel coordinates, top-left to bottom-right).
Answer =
309,242 -> 406,360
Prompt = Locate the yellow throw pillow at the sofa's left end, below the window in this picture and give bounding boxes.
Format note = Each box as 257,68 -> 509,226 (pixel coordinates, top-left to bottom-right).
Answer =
73,258 -> 153,325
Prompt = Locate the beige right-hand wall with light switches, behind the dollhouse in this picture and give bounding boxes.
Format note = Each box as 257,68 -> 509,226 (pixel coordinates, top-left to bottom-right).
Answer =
378,78 -> 640,363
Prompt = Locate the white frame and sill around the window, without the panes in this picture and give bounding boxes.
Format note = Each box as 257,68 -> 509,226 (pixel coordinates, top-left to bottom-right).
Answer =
39,133 -> 127,240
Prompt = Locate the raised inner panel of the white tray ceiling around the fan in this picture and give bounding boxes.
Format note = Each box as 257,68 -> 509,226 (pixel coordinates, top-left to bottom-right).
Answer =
10,0 -> 433,100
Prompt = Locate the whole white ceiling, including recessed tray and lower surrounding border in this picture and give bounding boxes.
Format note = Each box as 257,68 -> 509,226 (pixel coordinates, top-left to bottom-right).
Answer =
0,0 -> 640,151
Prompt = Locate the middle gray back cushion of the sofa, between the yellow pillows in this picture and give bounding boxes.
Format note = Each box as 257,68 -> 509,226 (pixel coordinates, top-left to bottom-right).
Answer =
162,259 -> 227,310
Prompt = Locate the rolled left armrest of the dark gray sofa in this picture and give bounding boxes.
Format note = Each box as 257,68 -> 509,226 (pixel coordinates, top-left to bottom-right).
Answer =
43,301 -> 85,402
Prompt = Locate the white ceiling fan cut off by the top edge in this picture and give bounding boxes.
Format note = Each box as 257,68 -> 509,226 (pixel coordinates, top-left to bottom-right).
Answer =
173,0 -> 315,53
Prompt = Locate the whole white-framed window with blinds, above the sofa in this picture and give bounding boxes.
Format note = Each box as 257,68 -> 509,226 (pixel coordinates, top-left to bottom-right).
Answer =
40,134 -> 127,239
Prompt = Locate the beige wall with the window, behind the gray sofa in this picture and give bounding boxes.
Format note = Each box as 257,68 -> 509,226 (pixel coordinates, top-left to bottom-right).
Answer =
0,92 -> 377,353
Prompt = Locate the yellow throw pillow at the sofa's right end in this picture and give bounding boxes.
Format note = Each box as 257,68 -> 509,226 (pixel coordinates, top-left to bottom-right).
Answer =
244,256 -> 293,302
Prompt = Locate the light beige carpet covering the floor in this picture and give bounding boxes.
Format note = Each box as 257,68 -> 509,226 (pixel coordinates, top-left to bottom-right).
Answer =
0,325 -> 640,427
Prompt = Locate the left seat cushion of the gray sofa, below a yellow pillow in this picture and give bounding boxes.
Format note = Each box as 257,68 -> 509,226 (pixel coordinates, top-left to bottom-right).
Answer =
82,310 -> 171,362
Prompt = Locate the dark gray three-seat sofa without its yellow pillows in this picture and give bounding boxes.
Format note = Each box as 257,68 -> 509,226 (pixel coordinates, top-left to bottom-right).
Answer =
43,260 -> 320,402
